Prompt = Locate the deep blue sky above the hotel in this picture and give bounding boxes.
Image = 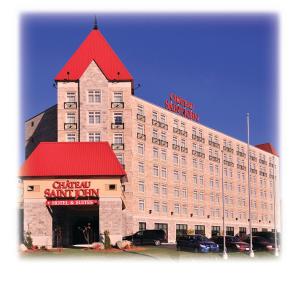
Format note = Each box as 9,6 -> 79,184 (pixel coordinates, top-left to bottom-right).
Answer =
19,12 -> 279,156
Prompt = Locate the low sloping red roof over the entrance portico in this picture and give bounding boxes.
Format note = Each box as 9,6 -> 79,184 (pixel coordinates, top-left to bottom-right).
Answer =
20,142 -> 126,177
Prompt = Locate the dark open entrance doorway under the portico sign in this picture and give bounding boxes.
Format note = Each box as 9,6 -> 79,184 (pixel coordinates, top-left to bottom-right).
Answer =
52,205 -> 99,247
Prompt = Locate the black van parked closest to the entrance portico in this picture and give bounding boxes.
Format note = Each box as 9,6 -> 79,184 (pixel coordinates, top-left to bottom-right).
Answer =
123,229 -> 167,246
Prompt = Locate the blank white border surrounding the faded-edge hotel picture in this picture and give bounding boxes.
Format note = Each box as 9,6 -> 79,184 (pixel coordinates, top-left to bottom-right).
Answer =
0,0 -> 300,299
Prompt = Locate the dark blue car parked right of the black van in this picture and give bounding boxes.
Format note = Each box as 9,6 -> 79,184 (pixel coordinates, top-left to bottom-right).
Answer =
176,235 -> 219,252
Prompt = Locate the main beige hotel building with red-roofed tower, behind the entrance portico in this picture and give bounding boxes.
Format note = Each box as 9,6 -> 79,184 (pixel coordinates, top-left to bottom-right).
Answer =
25,22 -> 279,242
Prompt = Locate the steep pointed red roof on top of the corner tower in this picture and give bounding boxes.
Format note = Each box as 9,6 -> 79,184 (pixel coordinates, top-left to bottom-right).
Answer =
55,29 -> 133,81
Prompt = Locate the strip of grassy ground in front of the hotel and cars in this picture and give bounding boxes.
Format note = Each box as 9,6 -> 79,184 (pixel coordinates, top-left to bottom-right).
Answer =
21,246 -> 278,261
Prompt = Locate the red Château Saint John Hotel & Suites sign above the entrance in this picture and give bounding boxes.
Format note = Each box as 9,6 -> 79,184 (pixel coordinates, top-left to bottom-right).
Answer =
44,180 -> 99,206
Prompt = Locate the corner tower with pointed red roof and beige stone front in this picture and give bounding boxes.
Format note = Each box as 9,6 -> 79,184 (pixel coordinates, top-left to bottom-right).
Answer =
55,26 -> 133,143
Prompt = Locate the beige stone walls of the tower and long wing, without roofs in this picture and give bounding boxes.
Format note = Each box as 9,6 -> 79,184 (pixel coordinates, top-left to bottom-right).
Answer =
57,62 -> 279,242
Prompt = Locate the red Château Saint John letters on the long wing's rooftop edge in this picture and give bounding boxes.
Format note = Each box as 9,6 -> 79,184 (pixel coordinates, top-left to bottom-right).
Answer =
165,93 -> 199,122
